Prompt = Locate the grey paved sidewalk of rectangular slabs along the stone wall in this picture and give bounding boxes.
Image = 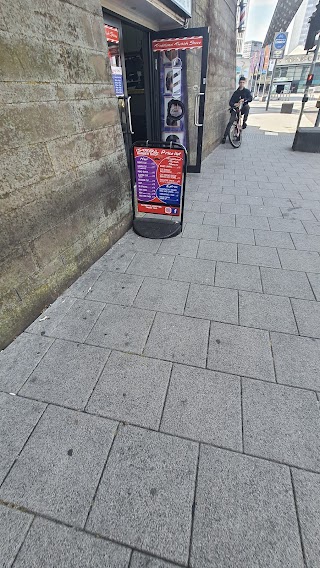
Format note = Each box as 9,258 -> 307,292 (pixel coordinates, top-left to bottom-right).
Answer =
0,128 -> 320,568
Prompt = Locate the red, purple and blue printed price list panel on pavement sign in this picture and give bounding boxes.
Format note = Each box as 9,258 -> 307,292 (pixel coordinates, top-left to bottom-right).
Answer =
134,146 -> 185,216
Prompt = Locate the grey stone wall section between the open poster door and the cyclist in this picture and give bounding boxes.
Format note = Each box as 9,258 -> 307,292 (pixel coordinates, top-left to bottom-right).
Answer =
190,0 -> 237,158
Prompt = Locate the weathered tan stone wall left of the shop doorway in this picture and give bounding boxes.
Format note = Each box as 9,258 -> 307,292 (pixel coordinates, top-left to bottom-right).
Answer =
0,0 -> 131,347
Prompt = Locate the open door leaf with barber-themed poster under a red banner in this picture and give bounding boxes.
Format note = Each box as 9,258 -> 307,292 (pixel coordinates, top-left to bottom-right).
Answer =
151,28 -> 209,173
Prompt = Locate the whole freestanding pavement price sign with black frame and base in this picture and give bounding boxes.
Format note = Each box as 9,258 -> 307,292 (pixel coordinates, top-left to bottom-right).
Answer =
131,141 -> 187,239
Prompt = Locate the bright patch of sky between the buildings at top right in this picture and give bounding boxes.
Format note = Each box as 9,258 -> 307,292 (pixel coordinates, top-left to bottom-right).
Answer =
245,0 -> 277,41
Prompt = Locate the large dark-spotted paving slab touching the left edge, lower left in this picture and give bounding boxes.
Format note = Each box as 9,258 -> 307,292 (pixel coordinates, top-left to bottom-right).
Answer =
0,403 -> 116,526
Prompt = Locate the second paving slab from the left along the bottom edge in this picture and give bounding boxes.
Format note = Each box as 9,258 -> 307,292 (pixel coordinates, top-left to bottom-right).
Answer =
15,518 -> 130,568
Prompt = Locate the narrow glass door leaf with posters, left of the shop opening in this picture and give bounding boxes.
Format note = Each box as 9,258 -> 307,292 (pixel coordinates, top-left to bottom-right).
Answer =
104,14 -> 133,162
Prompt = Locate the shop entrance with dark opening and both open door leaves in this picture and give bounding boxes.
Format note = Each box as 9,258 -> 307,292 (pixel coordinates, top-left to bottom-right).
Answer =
104,13 -> 208,172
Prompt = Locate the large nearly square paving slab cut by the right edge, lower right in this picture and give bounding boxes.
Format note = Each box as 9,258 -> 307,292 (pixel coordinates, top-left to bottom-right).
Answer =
242,379 -> 320,471
